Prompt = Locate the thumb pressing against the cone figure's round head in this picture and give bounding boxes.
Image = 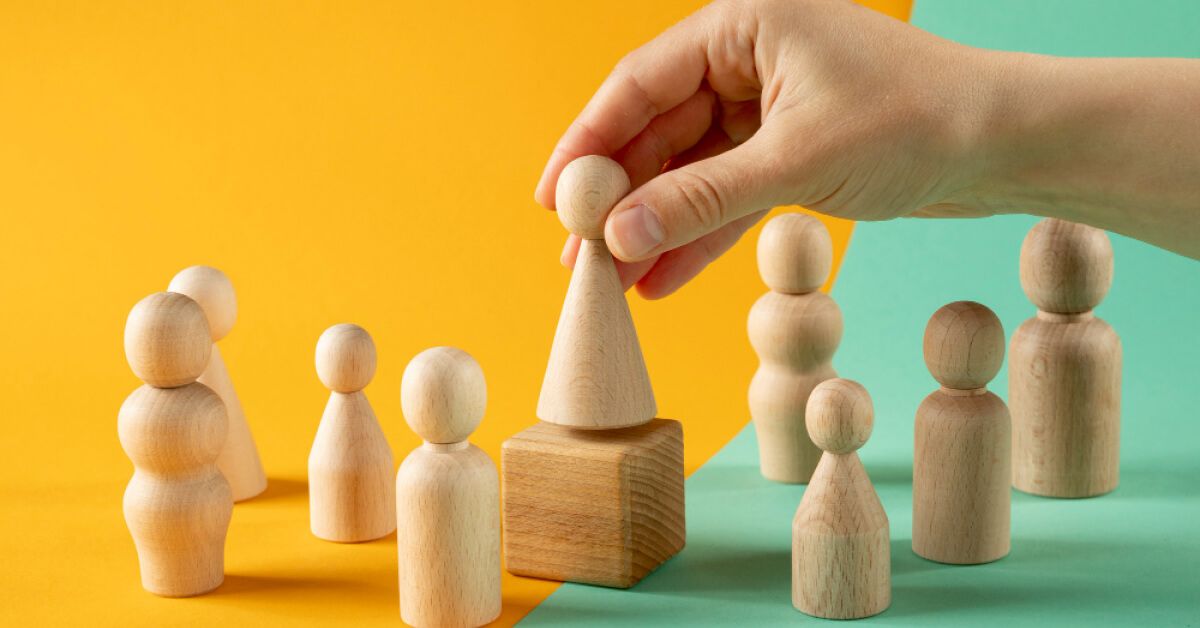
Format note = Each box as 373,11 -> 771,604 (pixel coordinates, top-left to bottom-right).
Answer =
605,130 -> 787,262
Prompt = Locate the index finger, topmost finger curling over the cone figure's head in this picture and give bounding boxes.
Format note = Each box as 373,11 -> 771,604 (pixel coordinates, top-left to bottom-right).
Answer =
534,14 -> 708,209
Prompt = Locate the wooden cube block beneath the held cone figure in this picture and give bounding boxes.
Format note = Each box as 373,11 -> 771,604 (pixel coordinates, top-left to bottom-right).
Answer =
500,419 -> 685,588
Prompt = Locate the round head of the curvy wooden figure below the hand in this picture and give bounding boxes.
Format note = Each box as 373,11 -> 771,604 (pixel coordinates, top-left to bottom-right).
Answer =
758,214 -> 833,294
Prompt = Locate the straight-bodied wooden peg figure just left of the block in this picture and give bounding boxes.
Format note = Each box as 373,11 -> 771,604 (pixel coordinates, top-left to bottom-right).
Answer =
396,347 -> 500,627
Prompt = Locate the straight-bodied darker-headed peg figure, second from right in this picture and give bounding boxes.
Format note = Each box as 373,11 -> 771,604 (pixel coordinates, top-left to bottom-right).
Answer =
912,301 -> 1013,564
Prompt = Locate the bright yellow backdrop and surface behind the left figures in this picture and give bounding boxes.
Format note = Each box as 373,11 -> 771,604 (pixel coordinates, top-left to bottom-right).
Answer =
0,0 -> 907,626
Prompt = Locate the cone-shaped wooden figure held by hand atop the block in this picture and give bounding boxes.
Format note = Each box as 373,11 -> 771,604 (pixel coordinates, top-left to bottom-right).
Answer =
538,155 -> 658,430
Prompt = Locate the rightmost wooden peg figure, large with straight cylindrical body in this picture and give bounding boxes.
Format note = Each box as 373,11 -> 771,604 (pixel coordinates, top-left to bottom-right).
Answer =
1008,219 -> 1121,497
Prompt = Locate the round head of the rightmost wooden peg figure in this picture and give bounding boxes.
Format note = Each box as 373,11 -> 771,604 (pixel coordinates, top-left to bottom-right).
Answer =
1021,219 -> 1112,313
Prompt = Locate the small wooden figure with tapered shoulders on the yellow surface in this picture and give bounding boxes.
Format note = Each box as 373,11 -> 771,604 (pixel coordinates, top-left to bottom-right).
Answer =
308,324 -> 396,543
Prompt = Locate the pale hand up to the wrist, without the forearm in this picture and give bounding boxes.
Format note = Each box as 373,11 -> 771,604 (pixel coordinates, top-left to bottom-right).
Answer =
535,0 -> 1000,299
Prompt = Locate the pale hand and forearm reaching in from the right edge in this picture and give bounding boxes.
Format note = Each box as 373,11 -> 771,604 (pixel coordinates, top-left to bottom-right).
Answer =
535,0 -> 1200,299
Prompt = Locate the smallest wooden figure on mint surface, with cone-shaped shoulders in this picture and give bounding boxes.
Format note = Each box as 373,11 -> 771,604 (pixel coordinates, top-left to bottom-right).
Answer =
792,379 -> 892,620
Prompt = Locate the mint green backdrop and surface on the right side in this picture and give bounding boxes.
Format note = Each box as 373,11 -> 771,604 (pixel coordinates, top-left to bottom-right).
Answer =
523,0 -> 1200,626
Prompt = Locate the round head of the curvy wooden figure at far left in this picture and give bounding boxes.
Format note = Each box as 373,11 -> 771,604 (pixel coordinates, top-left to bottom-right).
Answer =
125,292 -> 212,388
